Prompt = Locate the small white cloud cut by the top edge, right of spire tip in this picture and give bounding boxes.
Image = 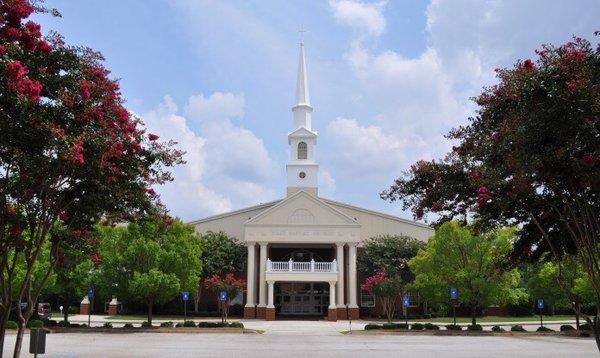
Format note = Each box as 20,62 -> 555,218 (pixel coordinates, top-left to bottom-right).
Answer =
329,0 -> 386,36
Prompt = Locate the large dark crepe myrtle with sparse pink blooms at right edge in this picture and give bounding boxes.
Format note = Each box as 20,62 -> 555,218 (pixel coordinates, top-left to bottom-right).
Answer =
382,33 -> 600,348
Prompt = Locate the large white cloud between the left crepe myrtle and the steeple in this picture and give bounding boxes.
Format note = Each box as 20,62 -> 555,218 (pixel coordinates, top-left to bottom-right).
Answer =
143,92 -> 278,220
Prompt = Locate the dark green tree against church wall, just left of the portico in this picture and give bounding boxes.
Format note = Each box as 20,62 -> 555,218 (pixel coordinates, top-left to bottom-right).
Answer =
194,231 -> 247,311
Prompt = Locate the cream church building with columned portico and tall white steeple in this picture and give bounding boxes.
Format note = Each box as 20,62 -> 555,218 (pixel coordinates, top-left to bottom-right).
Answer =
190,44 -> 434,321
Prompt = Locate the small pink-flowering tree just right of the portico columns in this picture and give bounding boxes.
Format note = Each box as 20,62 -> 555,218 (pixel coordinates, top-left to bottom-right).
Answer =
360,272 -> 402,323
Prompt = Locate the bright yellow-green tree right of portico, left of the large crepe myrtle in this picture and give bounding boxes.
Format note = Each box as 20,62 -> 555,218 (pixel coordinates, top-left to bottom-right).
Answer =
408,221 -> 525,325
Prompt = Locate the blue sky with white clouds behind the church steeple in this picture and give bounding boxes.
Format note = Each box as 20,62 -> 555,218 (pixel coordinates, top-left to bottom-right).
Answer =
37,0 -> 600,220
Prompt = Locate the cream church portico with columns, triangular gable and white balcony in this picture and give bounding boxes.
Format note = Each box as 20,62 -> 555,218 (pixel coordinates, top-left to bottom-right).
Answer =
244,190 -> 360,320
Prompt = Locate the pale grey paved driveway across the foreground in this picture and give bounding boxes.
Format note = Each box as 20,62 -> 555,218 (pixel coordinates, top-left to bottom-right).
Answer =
5,328 -> 598,358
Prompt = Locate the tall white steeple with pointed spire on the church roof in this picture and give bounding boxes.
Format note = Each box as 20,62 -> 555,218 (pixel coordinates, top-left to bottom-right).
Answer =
286,43 -> 319,196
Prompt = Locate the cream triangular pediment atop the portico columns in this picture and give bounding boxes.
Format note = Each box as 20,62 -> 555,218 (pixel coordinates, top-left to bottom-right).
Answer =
246,190 -> 360,227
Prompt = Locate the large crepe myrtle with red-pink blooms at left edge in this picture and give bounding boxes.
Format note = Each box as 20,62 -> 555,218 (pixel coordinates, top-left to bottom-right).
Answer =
0,0 -> 182,356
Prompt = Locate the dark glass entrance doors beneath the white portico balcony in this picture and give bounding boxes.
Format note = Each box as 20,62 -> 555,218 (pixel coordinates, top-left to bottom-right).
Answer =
275,282 -> 329,315
